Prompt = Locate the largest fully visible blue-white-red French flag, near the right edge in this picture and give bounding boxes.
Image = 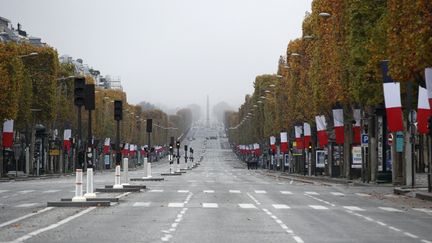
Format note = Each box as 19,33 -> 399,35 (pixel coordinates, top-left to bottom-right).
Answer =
381,61 -> 403,132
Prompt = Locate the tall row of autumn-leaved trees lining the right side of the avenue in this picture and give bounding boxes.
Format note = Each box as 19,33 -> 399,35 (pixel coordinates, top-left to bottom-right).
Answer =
225,0 -> 432,182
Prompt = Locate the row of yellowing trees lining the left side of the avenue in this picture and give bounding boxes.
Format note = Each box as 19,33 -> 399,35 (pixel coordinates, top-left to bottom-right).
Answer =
0,43 -> 193,152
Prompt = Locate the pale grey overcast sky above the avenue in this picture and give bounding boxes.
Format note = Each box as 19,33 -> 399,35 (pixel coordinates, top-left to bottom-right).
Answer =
0,0 -> 312,111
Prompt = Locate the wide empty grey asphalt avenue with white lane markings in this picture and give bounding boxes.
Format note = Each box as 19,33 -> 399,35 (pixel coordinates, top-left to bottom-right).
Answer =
0,128 -> 432,243
